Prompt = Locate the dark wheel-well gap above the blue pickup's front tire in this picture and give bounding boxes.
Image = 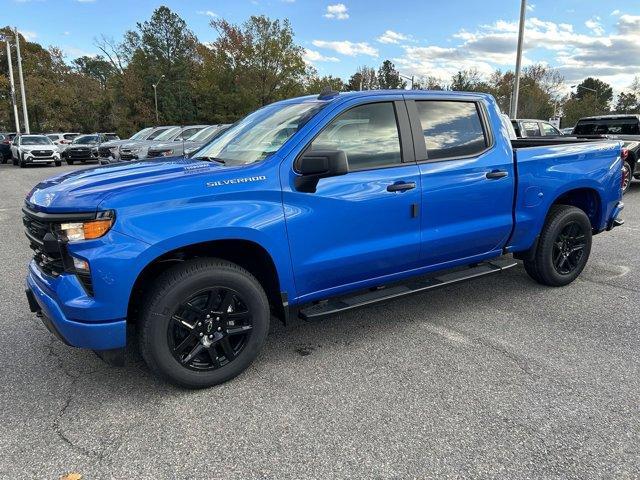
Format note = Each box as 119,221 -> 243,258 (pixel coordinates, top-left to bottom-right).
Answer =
127,238 -> 287,323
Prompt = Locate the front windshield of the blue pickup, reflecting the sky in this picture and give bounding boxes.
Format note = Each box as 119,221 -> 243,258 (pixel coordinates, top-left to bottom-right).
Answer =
194,101 -> 326,164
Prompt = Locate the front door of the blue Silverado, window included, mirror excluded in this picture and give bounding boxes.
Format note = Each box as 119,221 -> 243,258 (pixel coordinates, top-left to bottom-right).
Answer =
281,102 -> 420,300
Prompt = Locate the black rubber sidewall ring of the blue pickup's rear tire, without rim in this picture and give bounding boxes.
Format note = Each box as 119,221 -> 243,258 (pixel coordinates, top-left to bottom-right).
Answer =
537,207 -> 592,286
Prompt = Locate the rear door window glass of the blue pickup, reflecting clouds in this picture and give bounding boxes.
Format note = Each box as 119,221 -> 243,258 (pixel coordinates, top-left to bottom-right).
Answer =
415,100 -> 489,160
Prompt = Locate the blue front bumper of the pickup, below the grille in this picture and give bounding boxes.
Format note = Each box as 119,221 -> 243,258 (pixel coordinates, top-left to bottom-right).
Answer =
26,262 -> 127,350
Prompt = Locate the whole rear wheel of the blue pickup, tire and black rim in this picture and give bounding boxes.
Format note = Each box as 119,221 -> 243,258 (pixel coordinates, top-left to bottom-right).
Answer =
524,205 -> 592,287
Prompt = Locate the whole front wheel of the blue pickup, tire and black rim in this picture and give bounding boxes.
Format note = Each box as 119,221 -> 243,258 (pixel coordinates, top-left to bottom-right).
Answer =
139,259 -> 270,388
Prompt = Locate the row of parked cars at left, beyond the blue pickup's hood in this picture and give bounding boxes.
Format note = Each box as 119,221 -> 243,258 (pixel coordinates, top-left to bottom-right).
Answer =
0,124 -> 230,168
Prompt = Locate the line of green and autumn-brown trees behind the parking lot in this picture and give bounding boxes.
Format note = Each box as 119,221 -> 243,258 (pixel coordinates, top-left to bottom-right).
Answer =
0,6 -> 640,136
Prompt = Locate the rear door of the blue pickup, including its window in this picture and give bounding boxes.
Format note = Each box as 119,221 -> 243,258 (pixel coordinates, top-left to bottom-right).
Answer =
408,101 -> 514,266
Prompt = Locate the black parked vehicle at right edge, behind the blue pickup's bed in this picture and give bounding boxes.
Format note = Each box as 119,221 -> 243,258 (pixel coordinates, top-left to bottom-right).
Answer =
573,115 -> 640,192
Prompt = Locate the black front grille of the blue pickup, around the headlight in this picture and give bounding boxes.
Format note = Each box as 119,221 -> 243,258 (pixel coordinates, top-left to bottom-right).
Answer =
22,206 -> 93,296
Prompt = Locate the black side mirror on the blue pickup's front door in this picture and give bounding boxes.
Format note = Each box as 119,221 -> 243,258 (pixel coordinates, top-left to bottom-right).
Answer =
295,150 -> 349,193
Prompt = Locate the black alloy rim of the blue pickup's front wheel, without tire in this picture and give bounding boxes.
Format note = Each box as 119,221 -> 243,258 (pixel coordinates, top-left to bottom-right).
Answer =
167,287 -> 253,371
